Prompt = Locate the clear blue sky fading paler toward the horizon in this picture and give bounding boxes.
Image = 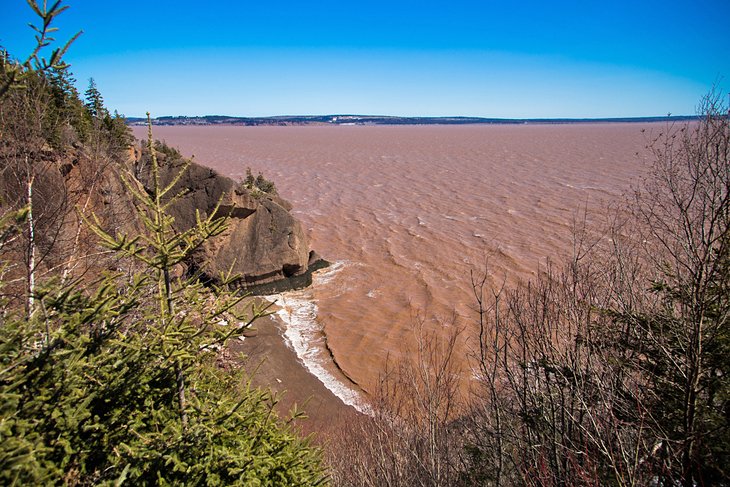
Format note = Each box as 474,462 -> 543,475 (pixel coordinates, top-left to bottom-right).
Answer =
0,0 -> 730,118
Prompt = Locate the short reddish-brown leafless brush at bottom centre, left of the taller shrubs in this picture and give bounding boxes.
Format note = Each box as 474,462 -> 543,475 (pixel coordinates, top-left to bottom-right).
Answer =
327,320 -> 462,486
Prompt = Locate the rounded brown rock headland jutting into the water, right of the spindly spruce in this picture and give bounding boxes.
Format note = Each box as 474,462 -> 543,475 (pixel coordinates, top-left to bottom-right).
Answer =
134,144 -> 316,292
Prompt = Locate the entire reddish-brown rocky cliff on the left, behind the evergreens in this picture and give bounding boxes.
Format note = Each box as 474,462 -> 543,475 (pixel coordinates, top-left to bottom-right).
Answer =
0,138 -> 322,294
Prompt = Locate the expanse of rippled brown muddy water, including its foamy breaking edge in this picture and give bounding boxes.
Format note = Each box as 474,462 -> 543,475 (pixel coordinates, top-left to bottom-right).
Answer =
134,124 -> 663,410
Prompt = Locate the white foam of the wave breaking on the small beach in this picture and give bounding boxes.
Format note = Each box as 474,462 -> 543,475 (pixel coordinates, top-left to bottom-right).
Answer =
266,262 -> 368,413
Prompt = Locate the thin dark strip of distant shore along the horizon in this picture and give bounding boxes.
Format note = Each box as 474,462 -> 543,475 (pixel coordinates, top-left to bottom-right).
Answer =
126,115 -> 698,127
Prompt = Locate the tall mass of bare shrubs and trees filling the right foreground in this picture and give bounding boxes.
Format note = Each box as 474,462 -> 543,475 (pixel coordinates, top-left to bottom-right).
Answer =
466,89 -> 730,486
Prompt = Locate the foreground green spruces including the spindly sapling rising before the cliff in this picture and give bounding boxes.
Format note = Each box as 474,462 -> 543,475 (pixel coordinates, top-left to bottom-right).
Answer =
0,117 -> 324,485
